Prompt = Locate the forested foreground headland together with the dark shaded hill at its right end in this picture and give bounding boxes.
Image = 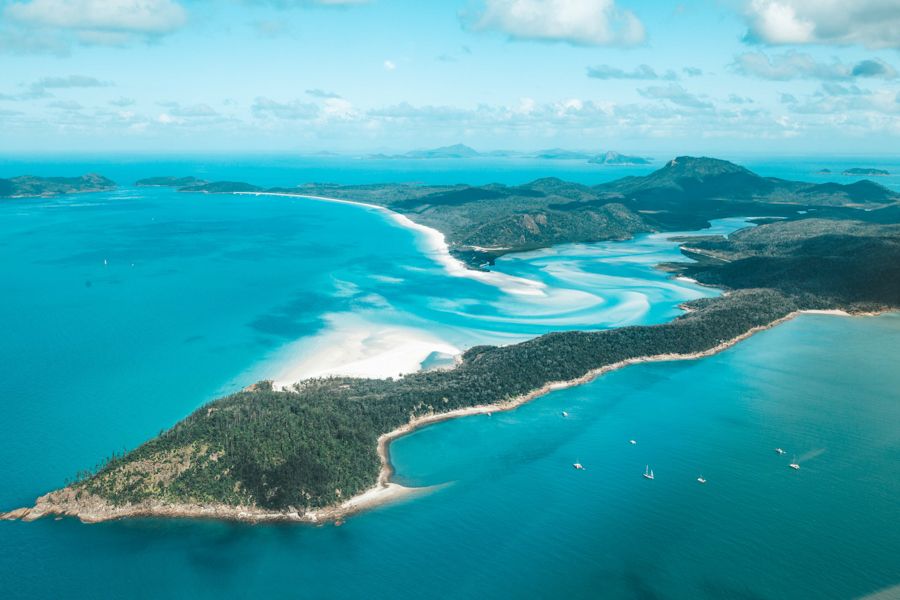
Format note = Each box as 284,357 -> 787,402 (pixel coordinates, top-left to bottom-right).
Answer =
8,218 -> 900,518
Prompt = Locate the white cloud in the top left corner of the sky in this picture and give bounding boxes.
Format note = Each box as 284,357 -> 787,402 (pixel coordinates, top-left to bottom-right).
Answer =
3,0 -> 187,46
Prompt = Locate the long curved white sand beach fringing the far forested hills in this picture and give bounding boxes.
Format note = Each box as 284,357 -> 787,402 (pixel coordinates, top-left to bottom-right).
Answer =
231,192 -> 547,296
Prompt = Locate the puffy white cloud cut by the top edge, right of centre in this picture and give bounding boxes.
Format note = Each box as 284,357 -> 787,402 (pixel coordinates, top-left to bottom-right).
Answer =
472,0 -> 645,46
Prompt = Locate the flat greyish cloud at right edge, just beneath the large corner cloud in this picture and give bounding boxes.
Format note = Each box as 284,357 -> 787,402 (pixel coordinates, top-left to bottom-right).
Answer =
731,52 -> 897,81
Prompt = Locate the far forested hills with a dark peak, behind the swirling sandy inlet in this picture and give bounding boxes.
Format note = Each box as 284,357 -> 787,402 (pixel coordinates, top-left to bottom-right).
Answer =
156,156 -> 900,267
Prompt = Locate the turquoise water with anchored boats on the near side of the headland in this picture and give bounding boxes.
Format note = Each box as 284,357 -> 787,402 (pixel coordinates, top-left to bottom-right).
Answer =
3,315 -> 900,599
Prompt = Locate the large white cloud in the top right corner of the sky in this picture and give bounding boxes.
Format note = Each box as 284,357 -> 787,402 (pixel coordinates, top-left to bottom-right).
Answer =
745,0 -> 900,48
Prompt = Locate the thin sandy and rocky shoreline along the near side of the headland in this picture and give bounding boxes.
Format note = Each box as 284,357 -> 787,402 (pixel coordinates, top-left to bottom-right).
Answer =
0,309 -> 888,524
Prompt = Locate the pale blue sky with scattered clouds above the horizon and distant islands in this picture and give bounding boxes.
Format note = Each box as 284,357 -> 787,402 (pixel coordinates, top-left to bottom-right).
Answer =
0,0 -> 900,156
